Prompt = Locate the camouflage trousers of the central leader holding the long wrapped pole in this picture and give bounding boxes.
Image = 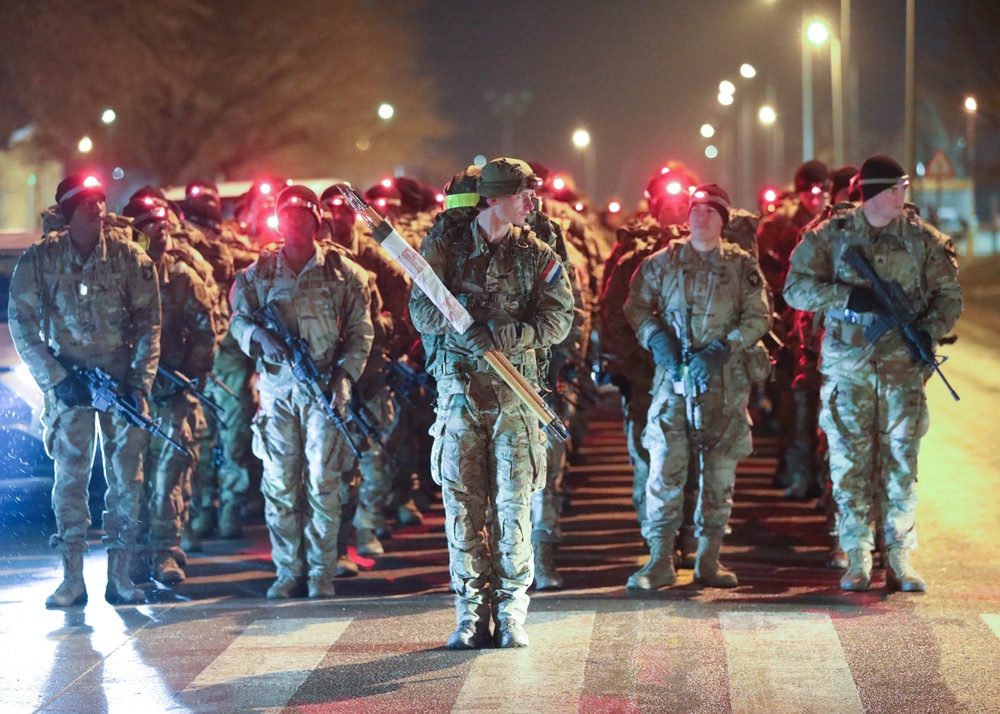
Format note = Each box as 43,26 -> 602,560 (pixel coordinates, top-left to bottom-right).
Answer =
430,372 -> 545,623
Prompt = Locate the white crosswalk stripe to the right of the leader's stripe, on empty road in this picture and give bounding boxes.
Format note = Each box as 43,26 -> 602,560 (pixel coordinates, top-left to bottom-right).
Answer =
719,612 -> 864,714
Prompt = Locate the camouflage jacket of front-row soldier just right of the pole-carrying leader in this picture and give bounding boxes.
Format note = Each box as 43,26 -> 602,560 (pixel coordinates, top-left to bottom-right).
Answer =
624,239 -> 770,384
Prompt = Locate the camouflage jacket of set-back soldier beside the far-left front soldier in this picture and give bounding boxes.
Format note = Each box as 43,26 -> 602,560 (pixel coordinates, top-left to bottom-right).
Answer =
156,251 -> 217,379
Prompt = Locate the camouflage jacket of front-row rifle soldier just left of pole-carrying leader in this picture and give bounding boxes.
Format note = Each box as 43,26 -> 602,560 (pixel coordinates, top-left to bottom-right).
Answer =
229,246 -> 373,401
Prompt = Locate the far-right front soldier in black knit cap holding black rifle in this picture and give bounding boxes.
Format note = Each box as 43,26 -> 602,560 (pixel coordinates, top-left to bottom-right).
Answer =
785,155 -> 962,592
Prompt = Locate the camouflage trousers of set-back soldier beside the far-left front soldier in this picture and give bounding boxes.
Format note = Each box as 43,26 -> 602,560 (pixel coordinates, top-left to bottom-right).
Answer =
140,393 -> 207,552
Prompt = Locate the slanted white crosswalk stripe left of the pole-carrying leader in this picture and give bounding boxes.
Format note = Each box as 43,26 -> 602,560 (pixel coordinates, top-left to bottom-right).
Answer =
184,618 -> 351,712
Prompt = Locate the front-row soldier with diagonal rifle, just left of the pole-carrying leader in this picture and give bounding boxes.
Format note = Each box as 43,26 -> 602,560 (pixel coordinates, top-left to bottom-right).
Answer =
230,186 -> 372,598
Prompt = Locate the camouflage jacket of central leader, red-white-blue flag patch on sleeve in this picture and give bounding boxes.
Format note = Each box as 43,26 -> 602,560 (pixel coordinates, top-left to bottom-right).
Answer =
410,218 -> 573,376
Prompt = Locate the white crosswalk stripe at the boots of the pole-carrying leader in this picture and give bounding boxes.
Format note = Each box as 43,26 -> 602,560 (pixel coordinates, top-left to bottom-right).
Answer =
452,612 -> 595,713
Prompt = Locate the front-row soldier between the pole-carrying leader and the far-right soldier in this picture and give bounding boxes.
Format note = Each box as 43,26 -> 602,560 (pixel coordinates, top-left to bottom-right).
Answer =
625,184 -> 770,590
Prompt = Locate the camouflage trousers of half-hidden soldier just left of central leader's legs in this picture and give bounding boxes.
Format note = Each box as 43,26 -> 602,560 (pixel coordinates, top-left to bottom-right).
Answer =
354,377 -> 396,530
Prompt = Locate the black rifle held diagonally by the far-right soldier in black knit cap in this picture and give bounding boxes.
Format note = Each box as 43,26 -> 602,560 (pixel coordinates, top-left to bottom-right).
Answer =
844,246 -> 958,402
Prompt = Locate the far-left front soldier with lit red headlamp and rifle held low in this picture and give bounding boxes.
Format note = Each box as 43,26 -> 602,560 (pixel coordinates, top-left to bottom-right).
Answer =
8,175 -> 160,607
